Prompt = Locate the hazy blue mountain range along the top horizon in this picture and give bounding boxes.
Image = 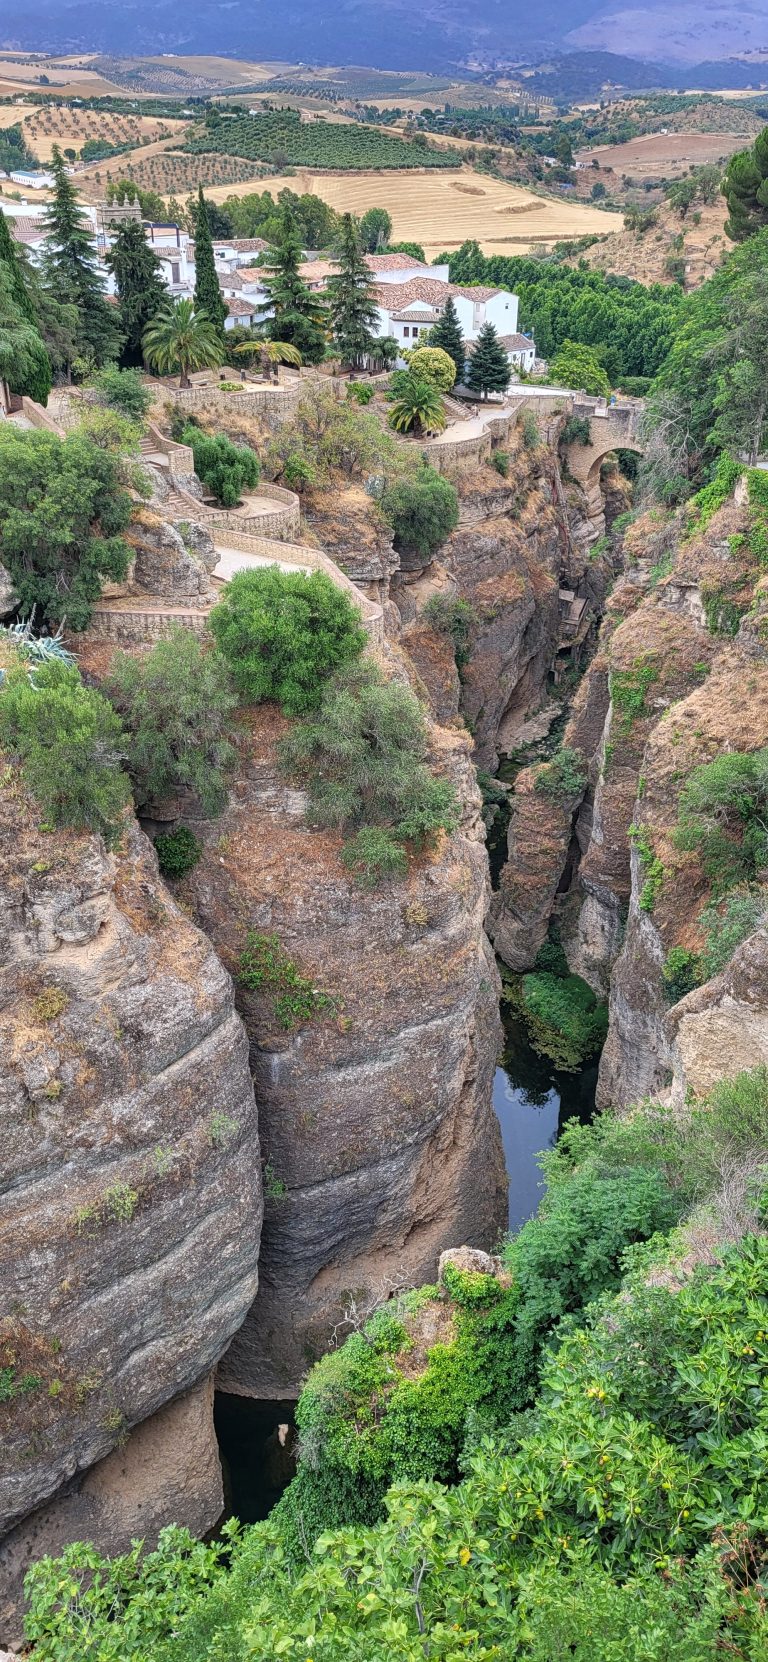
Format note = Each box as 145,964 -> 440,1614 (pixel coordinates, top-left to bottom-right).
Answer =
0,0 -> 768,85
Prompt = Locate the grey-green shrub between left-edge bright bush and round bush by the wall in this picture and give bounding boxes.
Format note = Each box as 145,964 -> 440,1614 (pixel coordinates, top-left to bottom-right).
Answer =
105,627 -> 238,814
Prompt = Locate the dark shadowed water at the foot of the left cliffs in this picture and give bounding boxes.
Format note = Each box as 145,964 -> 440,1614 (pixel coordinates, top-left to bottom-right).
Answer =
213,1391 -> 296,1524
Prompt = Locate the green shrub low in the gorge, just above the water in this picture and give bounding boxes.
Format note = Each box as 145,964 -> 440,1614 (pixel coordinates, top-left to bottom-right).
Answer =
520,971 -> 608,1072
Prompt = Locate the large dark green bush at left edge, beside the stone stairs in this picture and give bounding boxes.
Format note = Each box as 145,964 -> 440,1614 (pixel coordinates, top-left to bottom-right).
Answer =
0,422 -> 131,630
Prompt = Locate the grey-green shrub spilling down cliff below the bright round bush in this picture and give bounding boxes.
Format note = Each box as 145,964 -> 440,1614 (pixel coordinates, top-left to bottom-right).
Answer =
281,658 -> 459,849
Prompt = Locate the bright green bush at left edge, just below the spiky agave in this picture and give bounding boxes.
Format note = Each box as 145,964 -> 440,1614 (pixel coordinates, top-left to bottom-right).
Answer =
0,663 -> 131,844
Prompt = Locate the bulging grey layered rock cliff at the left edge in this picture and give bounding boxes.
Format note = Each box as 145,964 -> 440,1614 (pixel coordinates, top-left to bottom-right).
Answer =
0,794 -> 261,1635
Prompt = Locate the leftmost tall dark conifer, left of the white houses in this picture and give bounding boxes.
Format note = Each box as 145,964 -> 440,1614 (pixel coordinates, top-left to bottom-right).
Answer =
43,145 -> 120,364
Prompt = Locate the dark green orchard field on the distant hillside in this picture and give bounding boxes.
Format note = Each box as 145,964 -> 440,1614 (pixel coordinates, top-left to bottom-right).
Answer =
185,110 -> 454,170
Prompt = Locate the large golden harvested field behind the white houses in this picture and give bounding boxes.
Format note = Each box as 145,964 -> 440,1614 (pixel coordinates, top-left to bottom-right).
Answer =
206,170 -> 617,259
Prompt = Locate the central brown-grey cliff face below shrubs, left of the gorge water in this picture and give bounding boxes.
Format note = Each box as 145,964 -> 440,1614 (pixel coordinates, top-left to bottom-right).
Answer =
185,691 -> 505,1398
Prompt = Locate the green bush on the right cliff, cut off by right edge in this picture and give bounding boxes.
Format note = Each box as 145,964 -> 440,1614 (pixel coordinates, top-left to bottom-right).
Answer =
675,750 -> 768,894
